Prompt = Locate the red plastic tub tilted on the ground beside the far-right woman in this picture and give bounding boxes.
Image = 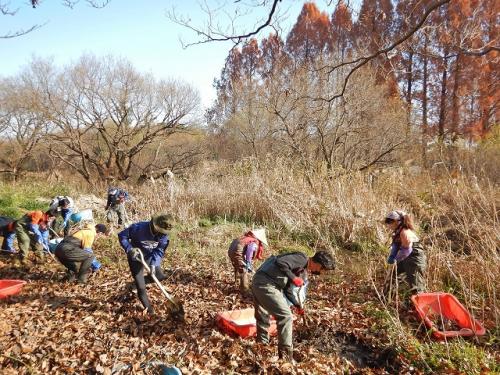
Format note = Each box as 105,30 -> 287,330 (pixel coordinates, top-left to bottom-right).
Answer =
411,293 -> 486,339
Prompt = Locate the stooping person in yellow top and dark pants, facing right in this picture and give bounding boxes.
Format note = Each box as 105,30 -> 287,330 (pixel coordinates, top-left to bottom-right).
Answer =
54,224 -> 108,284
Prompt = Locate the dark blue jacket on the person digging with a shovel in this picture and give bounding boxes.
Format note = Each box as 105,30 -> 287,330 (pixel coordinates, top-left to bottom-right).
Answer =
118,221 -> 170,267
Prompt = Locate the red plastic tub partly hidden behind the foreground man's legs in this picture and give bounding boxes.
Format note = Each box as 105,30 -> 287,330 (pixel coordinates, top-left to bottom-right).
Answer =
216,308 -> 277,337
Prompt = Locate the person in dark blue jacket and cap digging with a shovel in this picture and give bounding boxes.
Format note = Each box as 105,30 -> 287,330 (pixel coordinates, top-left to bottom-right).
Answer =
118,214 -> 172,314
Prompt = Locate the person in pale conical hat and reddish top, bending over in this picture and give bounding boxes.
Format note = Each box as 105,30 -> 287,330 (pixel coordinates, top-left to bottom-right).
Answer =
227,228 -> 268,295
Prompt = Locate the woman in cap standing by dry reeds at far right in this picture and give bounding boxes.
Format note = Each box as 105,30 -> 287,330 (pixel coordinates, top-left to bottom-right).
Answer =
384,211 -> 427,294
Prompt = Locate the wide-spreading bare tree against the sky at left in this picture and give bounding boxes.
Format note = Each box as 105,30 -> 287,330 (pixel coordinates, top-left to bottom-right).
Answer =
36,56 -> 199,183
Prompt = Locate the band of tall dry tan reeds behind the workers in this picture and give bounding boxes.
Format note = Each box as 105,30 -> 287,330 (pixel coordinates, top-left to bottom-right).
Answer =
120,159 -> 500,326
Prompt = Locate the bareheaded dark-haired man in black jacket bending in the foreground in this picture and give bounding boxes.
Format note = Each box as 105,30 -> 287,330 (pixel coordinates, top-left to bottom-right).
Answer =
252,250 -> 335,361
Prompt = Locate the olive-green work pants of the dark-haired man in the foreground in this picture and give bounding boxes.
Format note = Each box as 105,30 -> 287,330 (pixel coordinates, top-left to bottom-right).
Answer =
252,272 -> 293,354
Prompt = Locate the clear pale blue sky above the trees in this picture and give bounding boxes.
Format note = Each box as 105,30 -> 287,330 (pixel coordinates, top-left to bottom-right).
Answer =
0,0 -> 352,107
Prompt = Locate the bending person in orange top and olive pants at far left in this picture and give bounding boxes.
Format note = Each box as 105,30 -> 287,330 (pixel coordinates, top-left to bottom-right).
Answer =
14,210 -> 57,266
